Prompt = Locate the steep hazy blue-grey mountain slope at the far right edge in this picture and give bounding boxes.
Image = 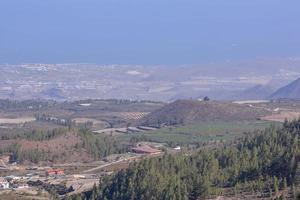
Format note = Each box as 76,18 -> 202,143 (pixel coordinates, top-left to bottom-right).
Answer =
269,78 -> 300,99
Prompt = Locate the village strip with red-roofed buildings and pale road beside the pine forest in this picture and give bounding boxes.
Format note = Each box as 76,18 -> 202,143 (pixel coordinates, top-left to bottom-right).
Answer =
0,143 -> 181,197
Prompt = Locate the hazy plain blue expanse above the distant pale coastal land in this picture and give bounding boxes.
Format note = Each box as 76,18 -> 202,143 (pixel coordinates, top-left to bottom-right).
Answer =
0,0 -> 300,64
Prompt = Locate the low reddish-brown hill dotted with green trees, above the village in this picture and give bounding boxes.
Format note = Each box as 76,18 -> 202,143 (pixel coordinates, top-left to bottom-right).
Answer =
0,128 -> 125,164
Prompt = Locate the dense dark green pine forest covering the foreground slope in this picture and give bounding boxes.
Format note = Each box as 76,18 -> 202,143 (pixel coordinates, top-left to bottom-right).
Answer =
82,120 -> 300,200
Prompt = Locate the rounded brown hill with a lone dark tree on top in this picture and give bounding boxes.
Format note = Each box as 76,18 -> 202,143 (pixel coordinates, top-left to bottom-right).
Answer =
139,100 -> 268,126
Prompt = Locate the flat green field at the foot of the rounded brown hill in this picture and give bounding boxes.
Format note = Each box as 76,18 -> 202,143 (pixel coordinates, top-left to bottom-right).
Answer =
120,121 -> 280,145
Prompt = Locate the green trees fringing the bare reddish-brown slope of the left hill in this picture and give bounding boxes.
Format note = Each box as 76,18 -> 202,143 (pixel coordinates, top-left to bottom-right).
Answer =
0,128 -> 127,163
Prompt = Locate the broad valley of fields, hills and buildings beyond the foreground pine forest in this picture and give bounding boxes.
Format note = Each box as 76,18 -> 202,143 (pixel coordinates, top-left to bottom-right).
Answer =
0,99 -> 300,199
